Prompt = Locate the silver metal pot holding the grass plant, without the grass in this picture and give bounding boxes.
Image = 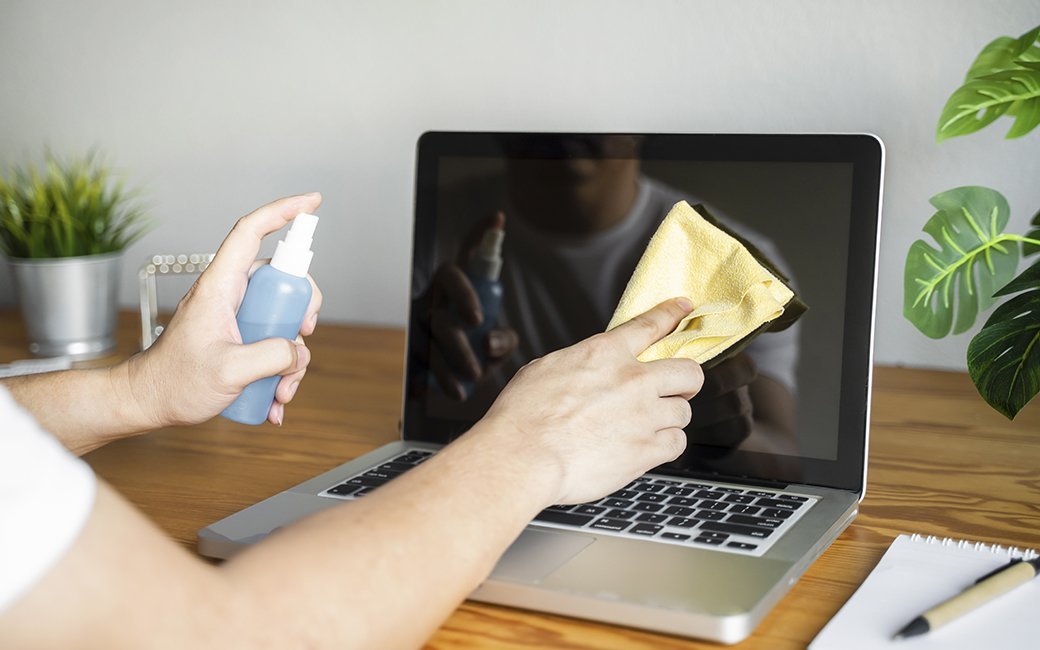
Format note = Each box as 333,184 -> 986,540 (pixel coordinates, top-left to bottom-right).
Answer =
7,252 -> 123,359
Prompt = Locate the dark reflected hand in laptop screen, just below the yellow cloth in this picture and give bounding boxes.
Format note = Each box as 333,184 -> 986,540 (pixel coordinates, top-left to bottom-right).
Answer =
686,353 -> 758,449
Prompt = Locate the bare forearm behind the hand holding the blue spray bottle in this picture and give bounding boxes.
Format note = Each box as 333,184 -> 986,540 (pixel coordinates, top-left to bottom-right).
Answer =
0,363 -> 158,456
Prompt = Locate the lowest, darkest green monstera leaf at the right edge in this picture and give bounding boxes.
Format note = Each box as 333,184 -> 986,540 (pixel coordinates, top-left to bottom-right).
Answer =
968,262 -> 1040,419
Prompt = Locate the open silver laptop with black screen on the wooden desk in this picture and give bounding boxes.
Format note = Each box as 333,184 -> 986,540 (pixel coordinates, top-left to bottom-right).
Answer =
198,132 -> 884,643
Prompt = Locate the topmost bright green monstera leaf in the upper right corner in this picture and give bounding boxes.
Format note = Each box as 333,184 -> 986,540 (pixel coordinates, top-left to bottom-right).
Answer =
936,27 -> 1040,141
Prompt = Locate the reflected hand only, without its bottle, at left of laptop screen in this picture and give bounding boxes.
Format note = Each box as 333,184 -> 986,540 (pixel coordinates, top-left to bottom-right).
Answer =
430,211 -> 520,400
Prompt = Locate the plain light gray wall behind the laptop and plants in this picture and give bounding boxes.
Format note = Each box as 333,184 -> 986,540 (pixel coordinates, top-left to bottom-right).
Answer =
0,0 -> 1040,368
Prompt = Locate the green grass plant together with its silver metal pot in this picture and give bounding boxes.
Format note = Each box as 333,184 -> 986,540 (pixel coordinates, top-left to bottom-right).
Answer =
0,153 -> 149,359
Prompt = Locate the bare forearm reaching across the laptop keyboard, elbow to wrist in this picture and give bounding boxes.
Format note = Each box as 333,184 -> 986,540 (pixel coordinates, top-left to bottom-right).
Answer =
224,418 -> 553,648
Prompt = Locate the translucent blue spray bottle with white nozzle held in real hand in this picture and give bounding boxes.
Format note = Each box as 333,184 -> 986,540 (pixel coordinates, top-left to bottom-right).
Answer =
220,213 -> 318,424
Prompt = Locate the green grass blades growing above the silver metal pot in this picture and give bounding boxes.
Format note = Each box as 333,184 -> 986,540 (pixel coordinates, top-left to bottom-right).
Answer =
0,153 -> 149,258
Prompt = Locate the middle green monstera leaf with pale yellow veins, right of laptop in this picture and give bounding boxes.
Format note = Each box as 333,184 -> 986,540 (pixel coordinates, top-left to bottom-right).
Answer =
903,187 -> 1022,338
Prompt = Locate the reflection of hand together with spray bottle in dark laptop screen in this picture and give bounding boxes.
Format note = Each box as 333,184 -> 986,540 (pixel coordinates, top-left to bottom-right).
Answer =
430,211 -> 519,400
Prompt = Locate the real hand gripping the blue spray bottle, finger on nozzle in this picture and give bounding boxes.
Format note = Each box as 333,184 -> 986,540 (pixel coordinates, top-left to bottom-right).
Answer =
126,192 -> 321,427
